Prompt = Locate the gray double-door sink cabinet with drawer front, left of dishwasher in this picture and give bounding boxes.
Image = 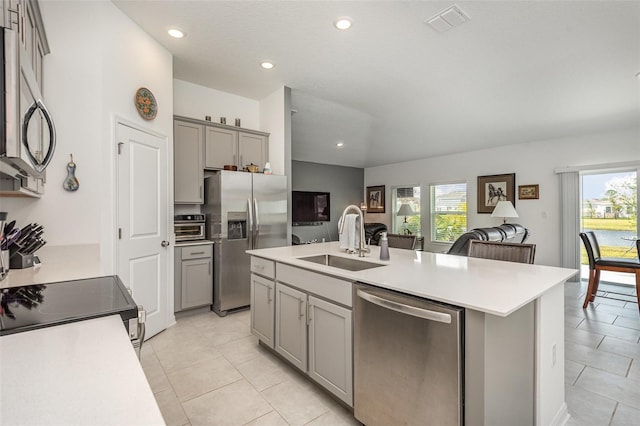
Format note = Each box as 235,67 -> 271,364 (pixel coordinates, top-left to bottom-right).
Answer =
272,263 -> 353,406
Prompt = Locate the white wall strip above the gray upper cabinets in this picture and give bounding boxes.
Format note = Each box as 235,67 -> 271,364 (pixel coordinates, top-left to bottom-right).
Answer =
173,79 -> 258,131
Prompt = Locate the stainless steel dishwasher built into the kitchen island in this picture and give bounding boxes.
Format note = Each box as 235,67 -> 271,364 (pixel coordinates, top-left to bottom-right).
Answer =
353,284 -> 464,426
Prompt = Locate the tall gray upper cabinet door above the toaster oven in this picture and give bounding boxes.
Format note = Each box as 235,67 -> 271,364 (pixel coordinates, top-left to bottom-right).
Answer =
173,121 -> 204,204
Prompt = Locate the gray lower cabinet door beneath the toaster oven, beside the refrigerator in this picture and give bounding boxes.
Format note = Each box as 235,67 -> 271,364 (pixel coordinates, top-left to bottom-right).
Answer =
182,257 -> 213,309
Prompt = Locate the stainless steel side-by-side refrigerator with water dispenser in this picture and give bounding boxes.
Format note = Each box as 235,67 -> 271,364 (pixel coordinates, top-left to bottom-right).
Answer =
202,171 -> 287,316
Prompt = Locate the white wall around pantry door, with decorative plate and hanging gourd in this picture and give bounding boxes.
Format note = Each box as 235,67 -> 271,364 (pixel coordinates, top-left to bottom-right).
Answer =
2,1 -> 173,272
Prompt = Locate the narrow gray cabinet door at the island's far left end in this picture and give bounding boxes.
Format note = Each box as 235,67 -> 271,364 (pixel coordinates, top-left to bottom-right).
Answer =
251,274 -> 275,348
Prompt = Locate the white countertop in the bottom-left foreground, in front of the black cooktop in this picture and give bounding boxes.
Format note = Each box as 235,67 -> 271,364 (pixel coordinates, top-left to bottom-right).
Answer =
0,315 -> 165,425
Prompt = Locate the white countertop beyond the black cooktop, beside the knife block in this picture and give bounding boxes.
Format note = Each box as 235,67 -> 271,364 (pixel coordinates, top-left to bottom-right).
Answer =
0,244 -> 104,288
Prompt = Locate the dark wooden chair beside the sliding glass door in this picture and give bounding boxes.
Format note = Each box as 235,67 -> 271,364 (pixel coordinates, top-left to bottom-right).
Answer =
580,232 -> 640,311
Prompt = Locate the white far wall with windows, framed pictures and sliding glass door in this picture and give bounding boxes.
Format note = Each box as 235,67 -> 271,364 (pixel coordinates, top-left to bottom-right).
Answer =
365,128 -> 640,266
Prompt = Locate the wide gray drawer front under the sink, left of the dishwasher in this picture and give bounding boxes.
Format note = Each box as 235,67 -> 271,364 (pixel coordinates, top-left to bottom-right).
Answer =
276,263 -> 352,308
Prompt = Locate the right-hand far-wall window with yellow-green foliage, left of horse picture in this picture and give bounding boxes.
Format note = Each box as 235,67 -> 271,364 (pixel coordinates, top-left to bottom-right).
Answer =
430,183 -> 467,243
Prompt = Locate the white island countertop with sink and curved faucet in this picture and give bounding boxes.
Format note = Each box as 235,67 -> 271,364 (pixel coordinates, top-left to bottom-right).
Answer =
247,242 -> 578,317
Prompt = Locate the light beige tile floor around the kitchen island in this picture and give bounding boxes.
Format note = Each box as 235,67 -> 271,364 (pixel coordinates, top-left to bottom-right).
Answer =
141,282 -> 640,426
